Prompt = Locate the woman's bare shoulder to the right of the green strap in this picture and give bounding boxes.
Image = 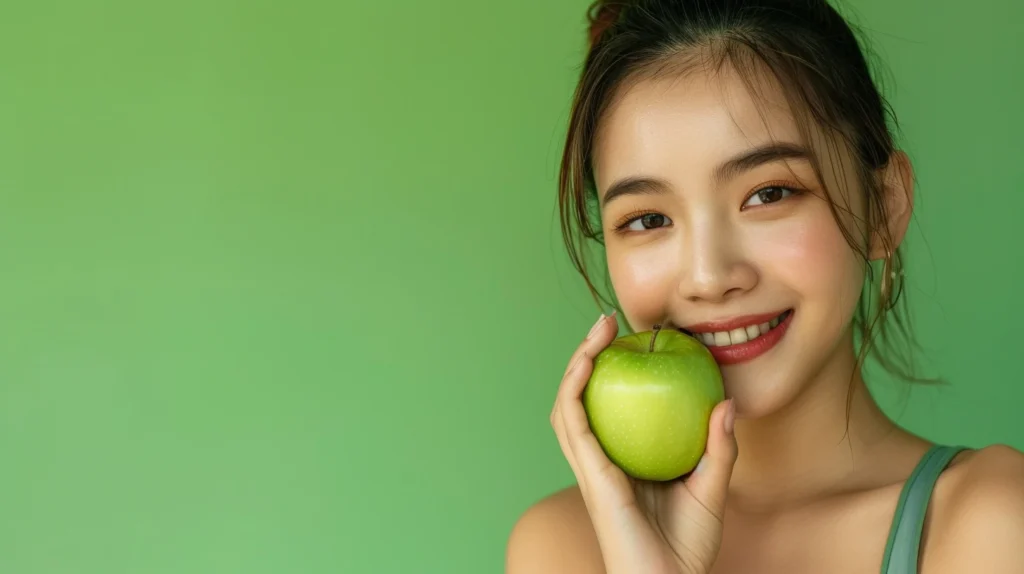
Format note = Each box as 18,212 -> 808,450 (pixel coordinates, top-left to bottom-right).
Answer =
922,445 -> 1024,574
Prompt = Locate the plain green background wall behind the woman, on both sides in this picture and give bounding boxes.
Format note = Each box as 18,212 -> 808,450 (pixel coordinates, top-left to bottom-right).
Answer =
0,0 -> 1024,574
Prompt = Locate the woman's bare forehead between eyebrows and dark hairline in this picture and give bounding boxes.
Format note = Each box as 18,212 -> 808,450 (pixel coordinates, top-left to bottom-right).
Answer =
594,65 -> 805,188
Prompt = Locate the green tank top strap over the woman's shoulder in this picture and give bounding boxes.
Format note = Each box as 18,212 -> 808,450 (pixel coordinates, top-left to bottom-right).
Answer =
882,445 -> 966,574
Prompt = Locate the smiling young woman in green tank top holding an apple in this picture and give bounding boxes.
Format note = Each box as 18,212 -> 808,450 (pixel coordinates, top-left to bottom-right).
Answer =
507,0 -> 1024,574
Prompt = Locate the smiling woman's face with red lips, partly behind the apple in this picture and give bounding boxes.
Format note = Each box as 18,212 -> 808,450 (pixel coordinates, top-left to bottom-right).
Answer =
594,69 -> 864,417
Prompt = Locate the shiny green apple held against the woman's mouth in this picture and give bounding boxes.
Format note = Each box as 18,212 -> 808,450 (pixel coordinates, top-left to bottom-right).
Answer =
583,325 -> 725,481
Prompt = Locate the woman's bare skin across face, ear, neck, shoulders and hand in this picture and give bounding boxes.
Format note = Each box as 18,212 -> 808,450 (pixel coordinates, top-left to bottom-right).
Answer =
506,62 -> 1024,574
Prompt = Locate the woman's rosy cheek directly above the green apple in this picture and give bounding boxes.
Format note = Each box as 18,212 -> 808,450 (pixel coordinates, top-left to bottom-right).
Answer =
606,241 -> 681,328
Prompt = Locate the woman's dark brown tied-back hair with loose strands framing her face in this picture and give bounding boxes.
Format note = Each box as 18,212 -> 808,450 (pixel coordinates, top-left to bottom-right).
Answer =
558,0 -> 928,382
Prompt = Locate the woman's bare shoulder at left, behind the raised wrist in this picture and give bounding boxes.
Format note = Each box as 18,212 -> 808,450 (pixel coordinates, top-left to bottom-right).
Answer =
505,486 -> 604,574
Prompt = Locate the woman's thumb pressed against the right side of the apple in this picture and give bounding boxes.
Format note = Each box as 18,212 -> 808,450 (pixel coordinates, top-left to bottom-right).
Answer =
686,399 -> 738,520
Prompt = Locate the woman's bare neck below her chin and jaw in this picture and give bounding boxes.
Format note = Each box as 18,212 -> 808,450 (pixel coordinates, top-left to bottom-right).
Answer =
730,342 -> 909,509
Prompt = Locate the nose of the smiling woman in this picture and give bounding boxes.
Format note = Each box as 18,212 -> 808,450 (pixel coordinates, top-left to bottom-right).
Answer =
679,218 -> 758,303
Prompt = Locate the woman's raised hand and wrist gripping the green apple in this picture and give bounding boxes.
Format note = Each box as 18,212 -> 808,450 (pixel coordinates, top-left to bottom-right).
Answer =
551,313 -> 736,574
